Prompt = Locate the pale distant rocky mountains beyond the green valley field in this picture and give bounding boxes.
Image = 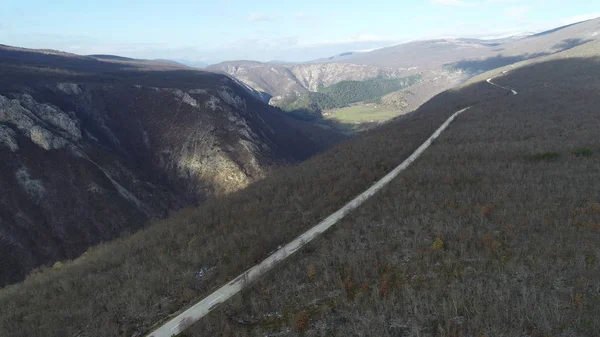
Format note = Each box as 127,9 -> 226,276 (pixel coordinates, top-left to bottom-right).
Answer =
207,19 -> 600,122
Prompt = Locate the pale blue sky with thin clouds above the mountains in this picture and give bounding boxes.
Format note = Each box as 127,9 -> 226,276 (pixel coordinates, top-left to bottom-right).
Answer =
0,0 -> 600,63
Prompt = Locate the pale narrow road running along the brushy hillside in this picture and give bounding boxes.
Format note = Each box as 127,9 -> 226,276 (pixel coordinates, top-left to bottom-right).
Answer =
148,78 -> 517,337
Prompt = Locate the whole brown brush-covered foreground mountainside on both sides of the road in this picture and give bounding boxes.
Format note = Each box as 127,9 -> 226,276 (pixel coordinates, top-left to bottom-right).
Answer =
0,35 -> 600,337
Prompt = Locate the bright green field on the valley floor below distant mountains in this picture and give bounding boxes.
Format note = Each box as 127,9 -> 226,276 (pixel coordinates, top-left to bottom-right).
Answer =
323,104 -> 399,123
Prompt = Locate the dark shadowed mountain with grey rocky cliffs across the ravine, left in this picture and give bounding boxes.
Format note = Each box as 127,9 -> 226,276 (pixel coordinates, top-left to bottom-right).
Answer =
0,47 -> 341,284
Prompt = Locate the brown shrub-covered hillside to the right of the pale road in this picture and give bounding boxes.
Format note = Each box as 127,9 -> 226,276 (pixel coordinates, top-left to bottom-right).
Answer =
186,54 -> 600,337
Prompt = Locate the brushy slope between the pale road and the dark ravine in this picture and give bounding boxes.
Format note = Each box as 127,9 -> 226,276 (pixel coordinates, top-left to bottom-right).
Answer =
0,59 -> 505,337
